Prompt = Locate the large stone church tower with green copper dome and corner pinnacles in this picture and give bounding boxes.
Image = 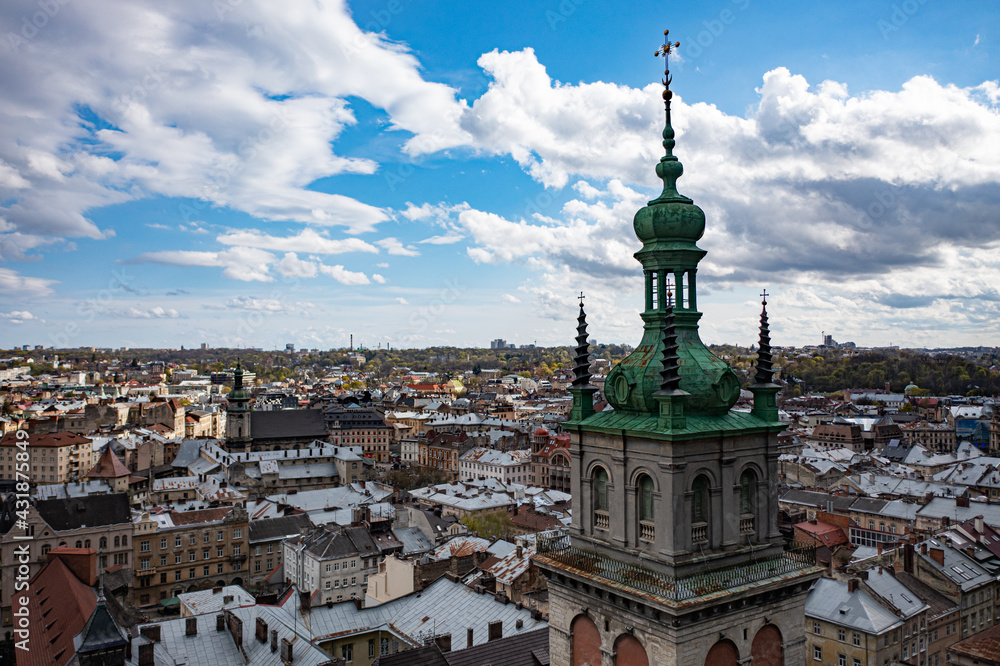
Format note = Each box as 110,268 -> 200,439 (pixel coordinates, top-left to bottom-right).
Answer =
536,33 -> 822,666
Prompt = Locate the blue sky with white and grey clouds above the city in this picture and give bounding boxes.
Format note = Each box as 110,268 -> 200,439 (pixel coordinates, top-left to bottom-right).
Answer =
0,0 -> 1000,349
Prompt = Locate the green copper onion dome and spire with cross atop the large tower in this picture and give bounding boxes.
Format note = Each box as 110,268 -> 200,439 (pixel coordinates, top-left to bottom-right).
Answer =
605,33 -> 740,415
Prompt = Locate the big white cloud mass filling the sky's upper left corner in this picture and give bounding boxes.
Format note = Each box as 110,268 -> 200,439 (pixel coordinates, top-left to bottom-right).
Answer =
0,0 -> 470,251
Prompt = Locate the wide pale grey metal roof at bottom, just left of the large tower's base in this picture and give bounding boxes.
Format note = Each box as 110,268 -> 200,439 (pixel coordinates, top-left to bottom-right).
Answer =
296,577 -> 548,645
